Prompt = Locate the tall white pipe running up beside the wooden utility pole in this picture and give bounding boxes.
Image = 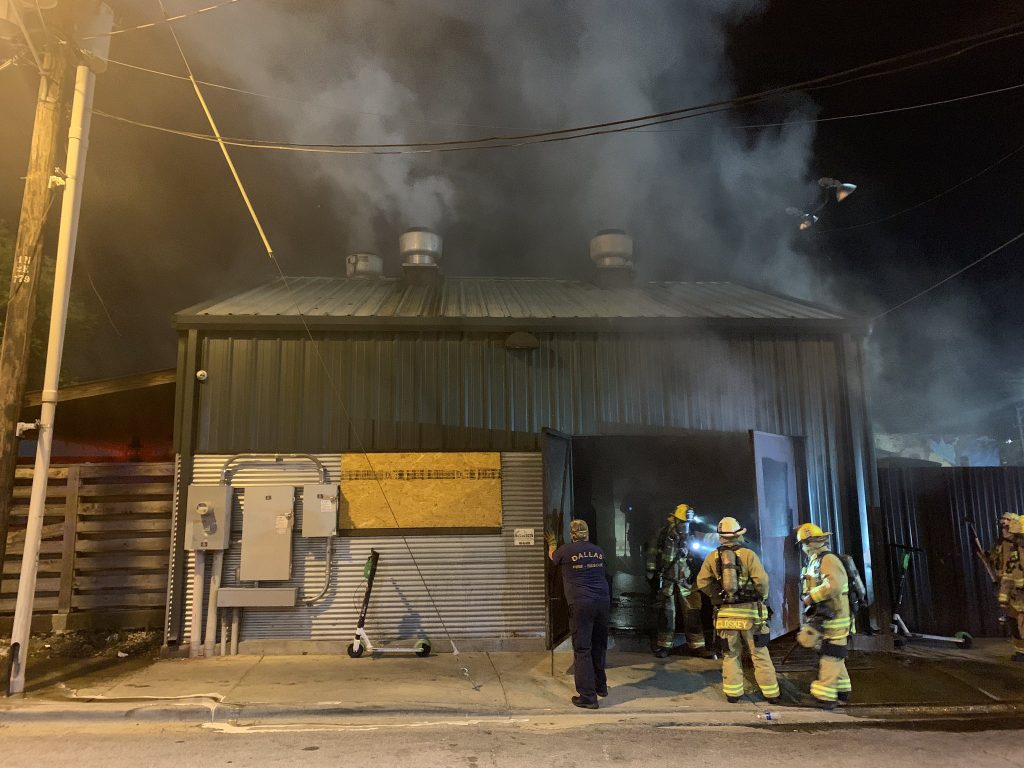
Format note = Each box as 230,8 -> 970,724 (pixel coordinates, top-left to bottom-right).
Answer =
7,65 -> 96,695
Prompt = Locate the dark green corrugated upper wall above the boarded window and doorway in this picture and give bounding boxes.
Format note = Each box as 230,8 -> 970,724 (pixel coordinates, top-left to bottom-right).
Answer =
190,330 -> 869,552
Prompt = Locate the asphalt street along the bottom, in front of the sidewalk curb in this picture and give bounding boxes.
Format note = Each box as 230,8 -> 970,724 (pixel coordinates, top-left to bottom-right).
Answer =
0,711 -> 1024,768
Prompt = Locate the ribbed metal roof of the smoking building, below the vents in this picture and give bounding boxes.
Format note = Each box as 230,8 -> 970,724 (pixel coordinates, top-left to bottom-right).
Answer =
176,278 -> 847,326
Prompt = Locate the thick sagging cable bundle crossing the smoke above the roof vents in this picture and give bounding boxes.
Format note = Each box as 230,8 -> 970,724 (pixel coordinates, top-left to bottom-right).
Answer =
92,22 -> 1024,154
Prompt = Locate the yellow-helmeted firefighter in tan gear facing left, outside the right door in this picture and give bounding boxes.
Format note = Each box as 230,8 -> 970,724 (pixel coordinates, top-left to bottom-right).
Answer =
797,522 -> 856,710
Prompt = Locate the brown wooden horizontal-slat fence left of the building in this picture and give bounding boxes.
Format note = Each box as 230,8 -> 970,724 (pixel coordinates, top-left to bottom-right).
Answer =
0,463 -> 174,630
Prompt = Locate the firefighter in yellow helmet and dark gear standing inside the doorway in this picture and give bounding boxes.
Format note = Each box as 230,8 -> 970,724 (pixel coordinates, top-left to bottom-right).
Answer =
647,504 -> 708,658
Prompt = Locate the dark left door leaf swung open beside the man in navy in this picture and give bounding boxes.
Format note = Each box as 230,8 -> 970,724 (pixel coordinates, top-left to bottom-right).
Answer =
543,428 -> 572,648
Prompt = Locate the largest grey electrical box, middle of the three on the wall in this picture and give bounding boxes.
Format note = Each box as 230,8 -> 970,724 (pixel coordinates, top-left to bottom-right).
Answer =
239,485 -> 295,582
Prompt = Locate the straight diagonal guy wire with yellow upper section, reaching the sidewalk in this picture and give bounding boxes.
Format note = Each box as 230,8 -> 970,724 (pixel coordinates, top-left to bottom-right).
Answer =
157,0 -> 480,690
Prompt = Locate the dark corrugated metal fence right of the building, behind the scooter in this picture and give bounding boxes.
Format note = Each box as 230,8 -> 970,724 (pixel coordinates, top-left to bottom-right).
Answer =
879,467 -> 1024,637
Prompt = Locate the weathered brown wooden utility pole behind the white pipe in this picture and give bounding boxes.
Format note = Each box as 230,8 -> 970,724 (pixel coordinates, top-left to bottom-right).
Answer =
0,44 -> 71,567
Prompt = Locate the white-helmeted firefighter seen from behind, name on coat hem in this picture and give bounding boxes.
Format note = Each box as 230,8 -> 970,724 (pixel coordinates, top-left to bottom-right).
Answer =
697,517 -> 779,703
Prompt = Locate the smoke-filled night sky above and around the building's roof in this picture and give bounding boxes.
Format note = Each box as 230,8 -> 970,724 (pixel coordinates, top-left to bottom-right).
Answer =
0,0 -> 1024,439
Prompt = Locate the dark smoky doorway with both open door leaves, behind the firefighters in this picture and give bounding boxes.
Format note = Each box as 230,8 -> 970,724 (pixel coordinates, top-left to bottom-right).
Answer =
545,431 -> 806,644
